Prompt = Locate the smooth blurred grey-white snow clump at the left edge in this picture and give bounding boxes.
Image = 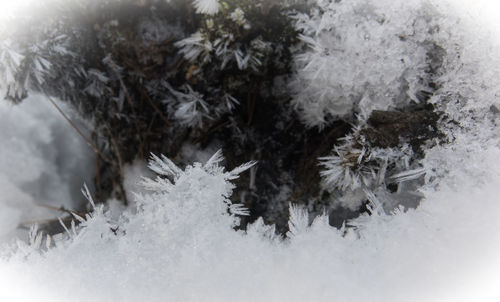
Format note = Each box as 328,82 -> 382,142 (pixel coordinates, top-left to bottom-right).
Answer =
0,96 -> 93,241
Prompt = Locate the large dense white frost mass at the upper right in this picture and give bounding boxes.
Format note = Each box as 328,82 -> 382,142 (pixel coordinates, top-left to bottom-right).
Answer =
289,0 -> 446,126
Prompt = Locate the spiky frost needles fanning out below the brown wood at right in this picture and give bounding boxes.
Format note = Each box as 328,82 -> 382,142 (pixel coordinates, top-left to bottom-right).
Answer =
319,127 -> 425,211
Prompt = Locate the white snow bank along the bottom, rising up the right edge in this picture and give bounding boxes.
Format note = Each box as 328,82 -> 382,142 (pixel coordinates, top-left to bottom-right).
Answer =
0,0 -> 500,302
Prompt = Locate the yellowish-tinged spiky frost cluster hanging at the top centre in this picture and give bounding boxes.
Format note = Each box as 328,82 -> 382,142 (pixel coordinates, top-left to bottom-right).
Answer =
176,1 -> 290,73
